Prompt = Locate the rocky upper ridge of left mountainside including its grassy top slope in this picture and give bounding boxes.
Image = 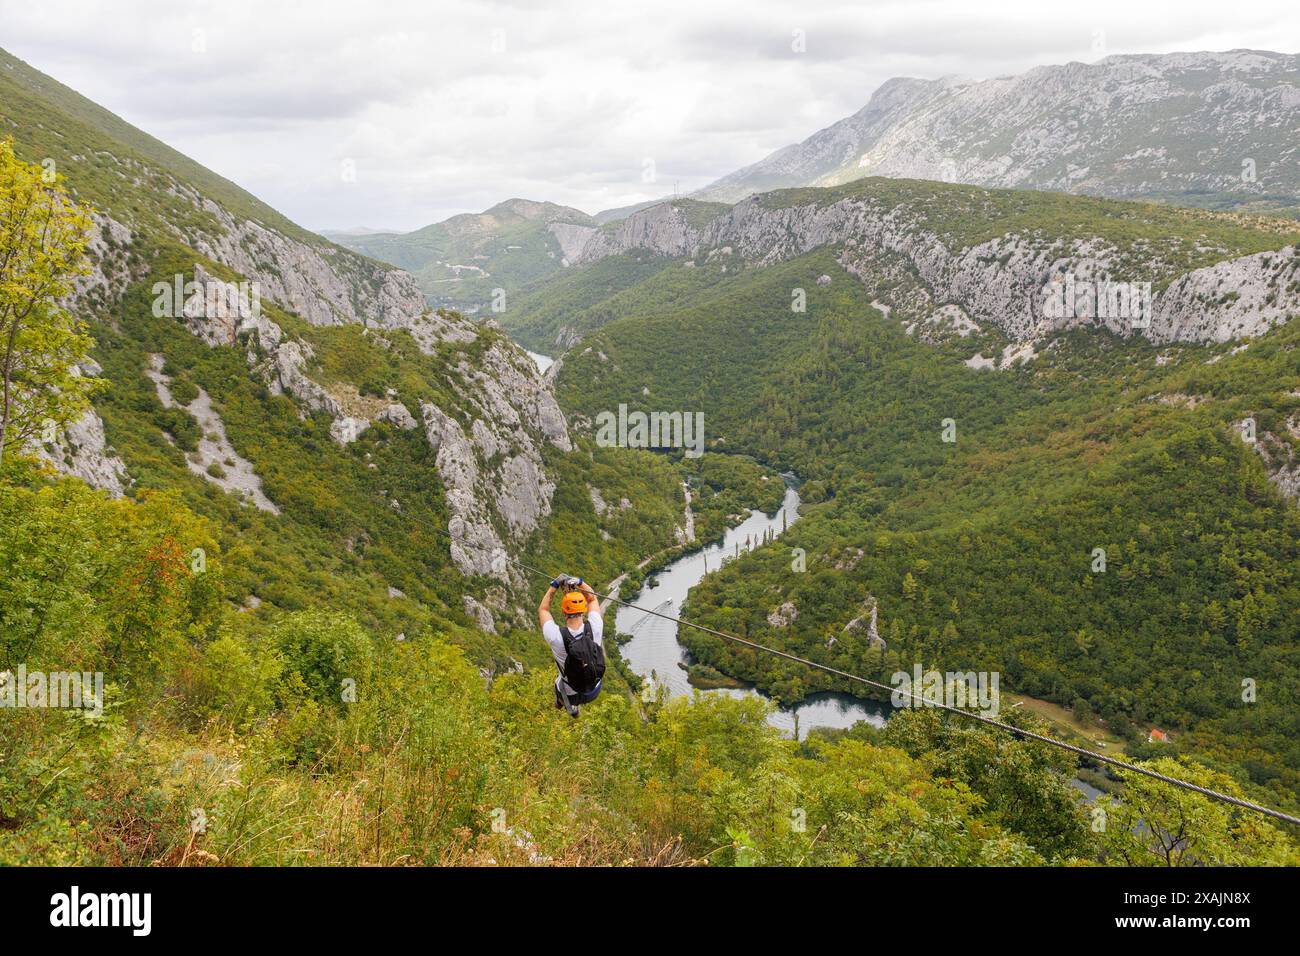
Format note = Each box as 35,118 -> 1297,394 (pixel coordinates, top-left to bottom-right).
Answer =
0,51 -> 569,606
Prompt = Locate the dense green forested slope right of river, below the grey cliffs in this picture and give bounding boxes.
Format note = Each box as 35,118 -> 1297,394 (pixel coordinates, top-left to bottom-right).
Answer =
559,239 -> 1300,805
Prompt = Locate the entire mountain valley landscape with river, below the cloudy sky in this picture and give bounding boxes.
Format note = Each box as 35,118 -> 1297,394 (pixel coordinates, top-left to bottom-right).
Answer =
0,33 -> 1300,866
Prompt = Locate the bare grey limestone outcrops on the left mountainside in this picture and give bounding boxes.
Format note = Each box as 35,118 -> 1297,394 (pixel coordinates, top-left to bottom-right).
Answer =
43,117 -> 577,618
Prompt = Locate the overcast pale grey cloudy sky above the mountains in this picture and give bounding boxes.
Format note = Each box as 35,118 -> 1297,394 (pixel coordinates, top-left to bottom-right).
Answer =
0,0 -> 1300,230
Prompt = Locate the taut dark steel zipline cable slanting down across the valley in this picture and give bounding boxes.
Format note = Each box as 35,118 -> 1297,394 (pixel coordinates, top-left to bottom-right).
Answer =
417,519 -> 1300,826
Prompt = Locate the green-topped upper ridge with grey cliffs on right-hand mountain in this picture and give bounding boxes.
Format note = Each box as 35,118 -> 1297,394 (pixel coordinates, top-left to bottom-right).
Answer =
502,178 -> 1300,351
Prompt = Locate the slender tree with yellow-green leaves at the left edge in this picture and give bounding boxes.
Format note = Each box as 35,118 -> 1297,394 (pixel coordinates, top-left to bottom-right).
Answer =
0,140 -> 101,462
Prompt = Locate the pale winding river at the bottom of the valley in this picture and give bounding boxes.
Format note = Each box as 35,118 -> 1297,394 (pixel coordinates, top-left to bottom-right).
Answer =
615,485 -> 889,740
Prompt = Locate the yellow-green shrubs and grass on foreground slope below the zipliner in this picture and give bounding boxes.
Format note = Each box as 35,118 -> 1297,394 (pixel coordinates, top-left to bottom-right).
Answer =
0,471 -> 1297,866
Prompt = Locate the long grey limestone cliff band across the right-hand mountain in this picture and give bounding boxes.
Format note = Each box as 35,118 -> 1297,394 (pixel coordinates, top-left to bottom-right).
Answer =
561,182 -> 1300,342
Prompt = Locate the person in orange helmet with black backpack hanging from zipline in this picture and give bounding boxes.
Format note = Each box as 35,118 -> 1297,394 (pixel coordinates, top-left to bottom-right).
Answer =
537,578 -> 605,717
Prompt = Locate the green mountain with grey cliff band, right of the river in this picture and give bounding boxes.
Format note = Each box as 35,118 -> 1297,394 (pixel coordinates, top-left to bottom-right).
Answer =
540,191 -> 1300,806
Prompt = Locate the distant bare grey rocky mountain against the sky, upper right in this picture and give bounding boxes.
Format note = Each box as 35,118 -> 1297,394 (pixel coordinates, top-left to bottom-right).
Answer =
696,49 -> 1300,203
